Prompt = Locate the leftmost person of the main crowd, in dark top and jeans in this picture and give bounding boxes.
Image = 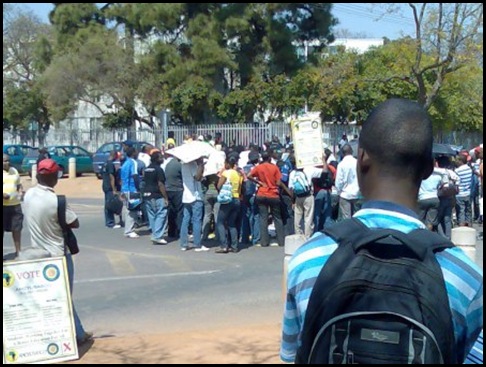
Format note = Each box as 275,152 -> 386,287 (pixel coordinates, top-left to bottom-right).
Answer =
101,150 -> 123,229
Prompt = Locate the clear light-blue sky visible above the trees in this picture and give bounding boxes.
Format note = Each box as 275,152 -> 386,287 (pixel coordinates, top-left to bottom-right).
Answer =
14,3 -> 414,39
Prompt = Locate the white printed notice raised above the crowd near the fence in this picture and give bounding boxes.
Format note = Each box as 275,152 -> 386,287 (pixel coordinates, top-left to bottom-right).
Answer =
292,117 -> 324,168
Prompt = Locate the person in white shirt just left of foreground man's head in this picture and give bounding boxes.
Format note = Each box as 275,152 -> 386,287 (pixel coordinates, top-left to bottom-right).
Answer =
336,144 -> 359,219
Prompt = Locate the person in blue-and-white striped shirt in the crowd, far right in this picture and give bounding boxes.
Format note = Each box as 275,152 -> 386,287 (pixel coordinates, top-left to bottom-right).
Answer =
456,154 -> 473,226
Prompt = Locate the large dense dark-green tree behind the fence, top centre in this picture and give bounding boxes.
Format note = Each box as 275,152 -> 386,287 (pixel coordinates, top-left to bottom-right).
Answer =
43,3 -> 336,123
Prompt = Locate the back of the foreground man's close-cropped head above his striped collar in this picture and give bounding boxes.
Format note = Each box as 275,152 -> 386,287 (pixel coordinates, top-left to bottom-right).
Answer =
358,98 -> 433,201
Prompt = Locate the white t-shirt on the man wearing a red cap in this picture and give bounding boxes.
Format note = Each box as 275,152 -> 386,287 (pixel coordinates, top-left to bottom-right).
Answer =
24,185 -> 78,257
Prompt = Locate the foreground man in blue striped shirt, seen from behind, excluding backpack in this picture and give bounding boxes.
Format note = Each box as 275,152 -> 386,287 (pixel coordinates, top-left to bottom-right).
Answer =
280,99 -> 483,362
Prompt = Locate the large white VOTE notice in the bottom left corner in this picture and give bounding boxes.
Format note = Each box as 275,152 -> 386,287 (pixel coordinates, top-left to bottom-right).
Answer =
3,257 -> 78,364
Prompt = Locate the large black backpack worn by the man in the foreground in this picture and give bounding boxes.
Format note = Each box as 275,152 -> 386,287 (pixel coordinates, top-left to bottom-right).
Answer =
296,218 -> 458,364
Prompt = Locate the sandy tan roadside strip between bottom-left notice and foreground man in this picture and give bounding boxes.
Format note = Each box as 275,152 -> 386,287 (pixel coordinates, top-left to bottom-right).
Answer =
66,325 -> 280,364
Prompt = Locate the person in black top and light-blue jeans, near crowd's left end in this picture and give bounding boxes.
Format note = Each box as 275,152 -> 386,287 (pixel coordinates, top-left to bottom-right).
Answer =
143,150 -> 169,245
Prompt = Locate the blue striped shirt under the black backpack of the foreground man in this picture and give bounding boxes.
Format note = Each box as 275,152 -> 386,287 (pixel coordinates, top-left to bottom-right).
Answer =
280,201 -> 483,362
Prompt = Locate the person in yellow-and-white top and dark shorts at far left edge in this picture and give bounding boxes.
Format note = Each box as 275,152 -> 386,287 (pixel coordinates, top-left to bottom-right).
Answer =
2,154 -> 24,257
